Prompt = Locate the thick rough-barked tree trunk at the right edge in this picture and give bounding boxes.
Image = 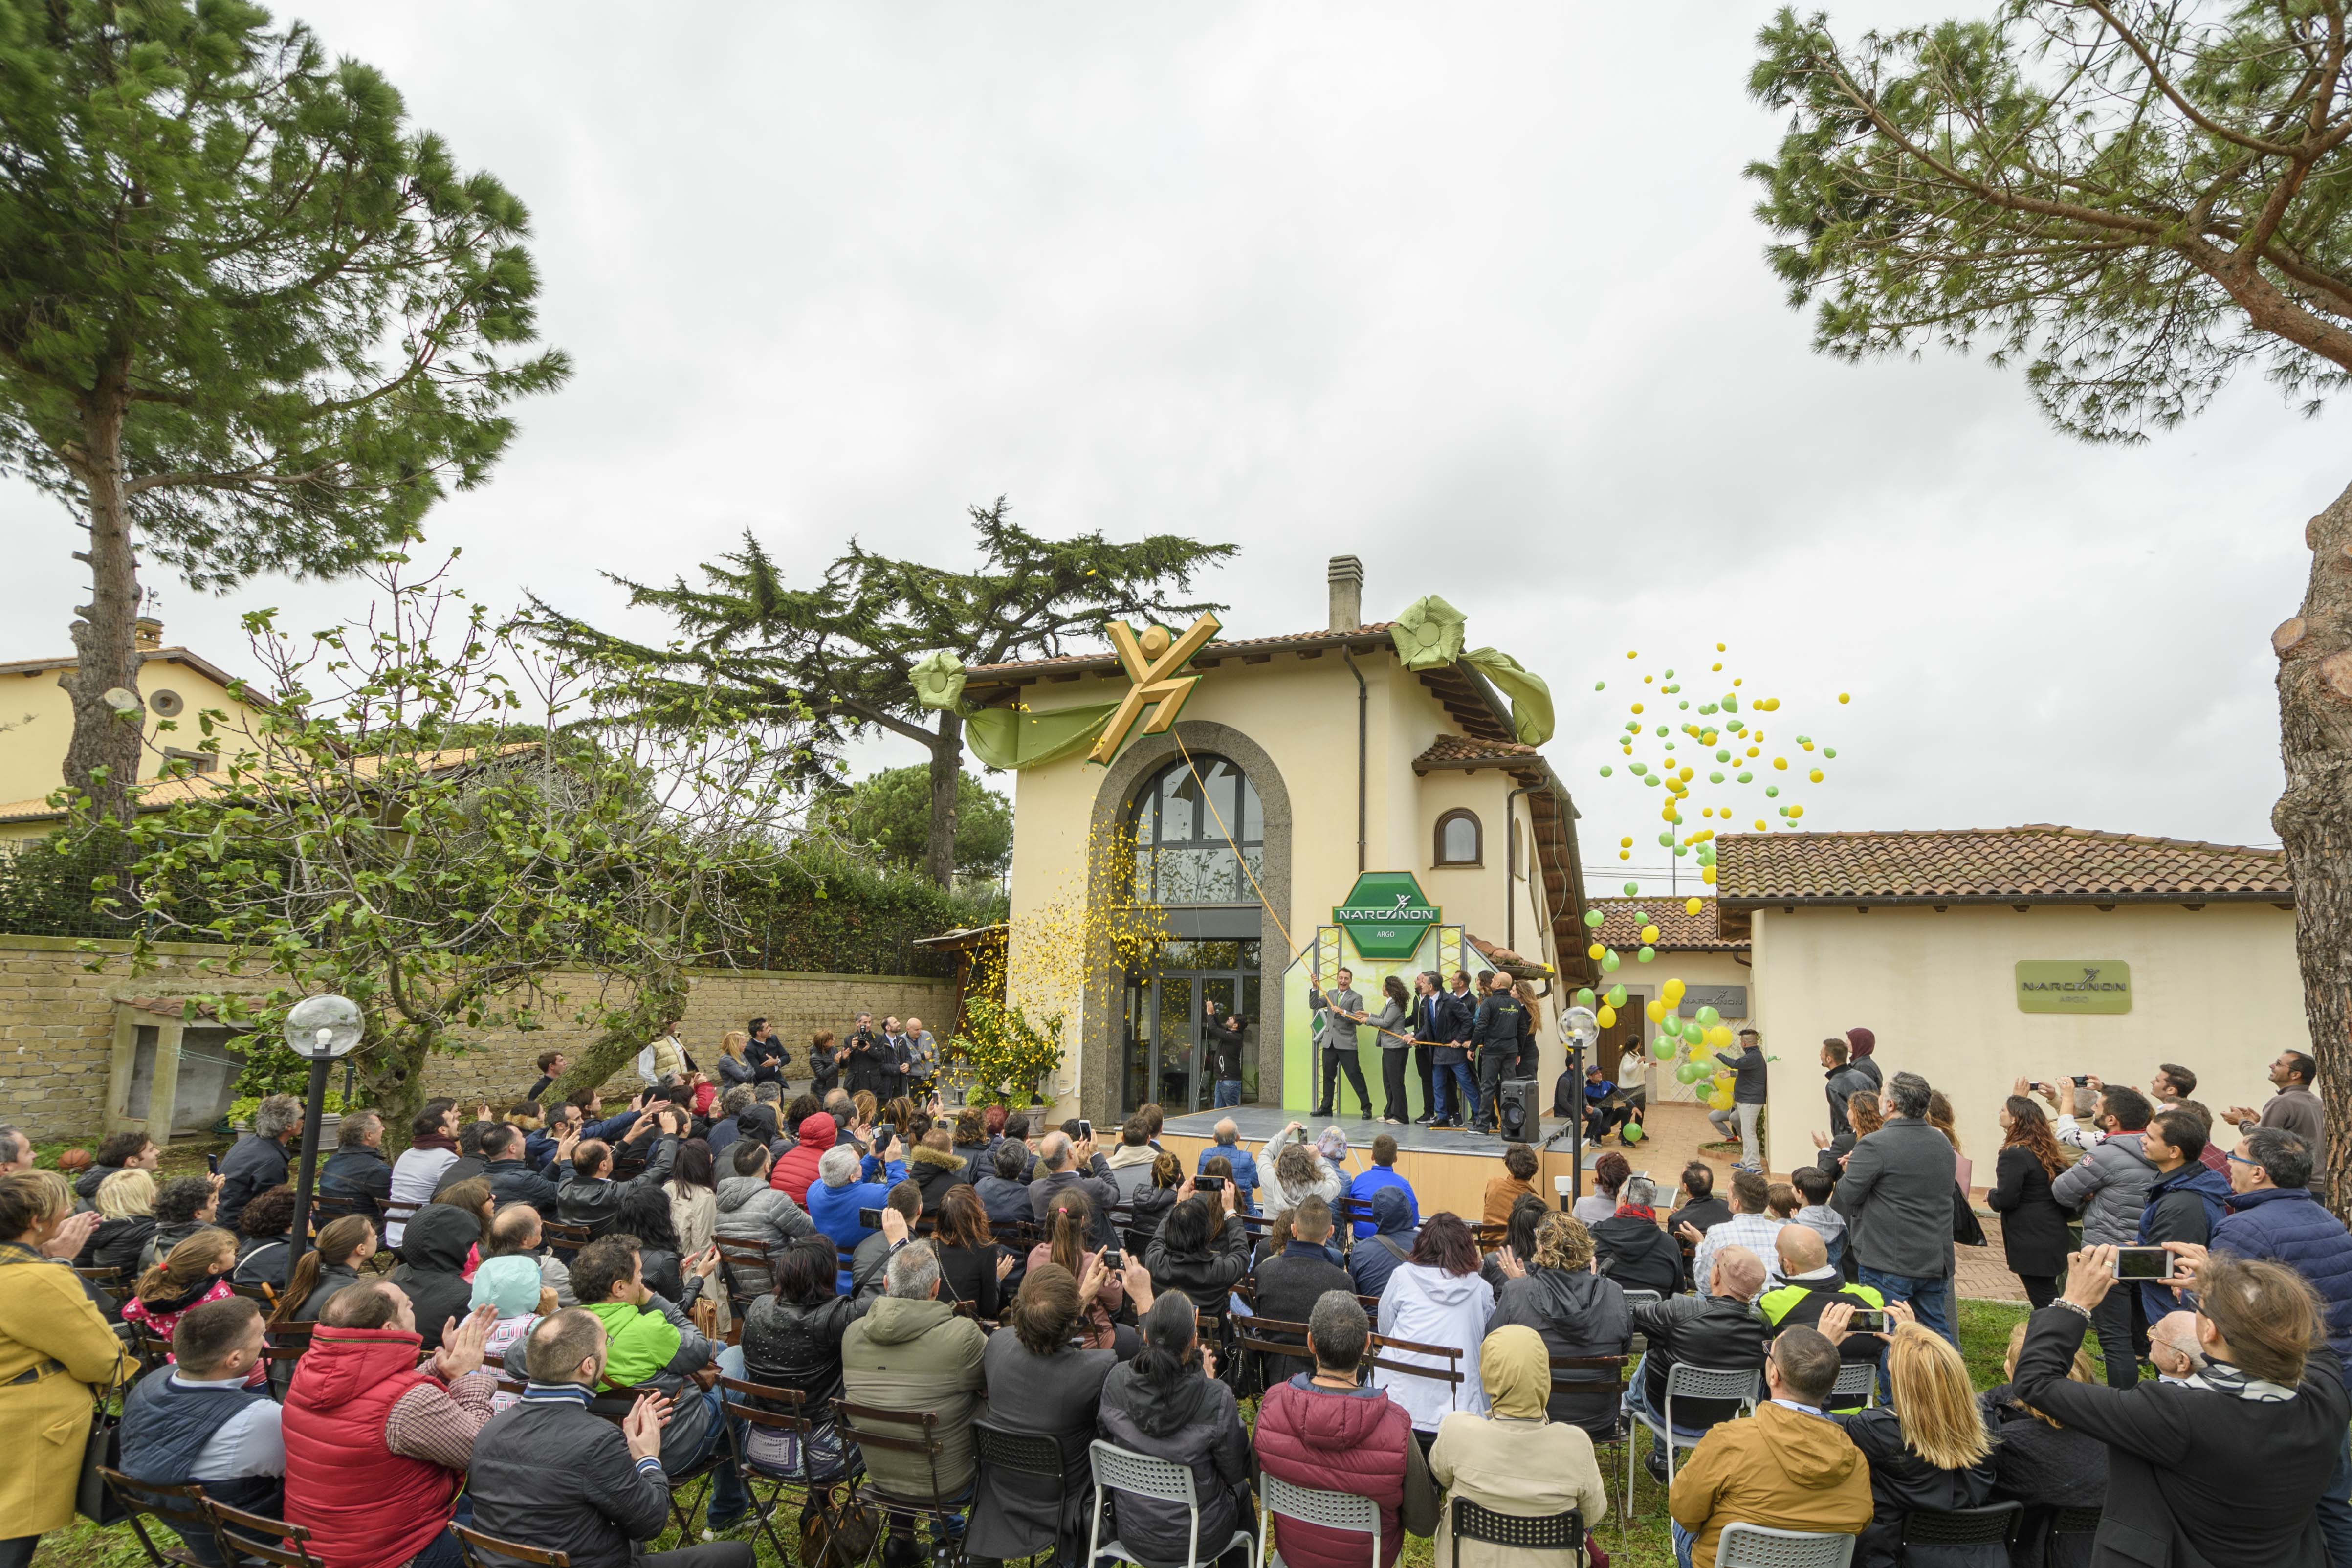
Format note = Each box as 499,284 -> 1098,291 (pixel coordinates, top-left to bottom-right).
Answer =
2270,489 -> 2352,1215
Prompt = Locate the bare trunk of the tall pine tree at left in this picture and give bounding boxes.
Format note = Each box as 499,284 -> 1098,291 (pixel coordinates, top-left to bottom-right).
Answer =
56,376 -> 146,820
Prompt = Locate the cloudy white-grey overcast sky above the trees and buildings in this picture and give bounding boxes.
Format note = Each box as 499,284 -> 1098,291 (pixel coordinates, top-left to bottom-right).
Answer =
0,0 -> 2352,882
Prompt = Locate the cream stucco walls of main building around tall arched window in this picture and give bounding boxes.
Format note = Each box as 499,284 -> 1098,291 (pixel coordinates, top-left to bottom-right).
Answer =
1007,651 -> 1555,1100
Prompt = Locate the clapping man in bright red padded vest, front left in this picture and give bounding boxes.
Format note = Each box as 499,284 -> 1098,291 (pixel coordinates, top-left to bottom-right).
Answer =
282,1279 -> 499,1568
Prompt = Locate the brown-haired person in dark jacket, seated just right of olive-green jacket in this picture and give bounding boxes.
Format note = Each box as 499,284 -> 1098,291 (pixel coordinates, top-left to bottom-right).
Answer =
965,1262 -> 1129,1561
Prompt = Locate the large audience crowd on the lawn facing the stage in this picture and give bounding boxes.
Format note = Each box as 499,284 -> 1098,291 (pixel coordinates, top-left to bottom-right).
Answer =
18,1034 -> 2352,1568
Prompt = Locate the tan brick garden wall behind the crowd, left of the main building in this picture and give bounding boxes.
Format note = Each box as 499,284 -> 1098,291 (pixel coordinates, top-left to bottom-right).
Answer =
0,936 -> 955,1143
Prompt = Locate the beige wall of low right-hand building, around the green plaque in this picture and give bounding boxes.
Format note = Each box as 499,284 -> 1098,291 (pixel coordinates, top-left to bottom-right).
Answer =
1755,903 -> 2309,1185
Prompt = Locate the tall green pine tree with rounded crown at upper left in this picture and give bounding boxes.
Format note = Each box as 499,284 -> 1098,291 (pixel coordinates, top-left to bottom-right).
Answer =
0,0 -> 567,814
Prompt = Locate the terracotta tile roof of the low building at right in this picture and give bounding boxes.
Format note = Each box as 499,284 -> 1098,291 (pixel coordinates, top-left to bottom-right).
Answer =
1715,823 -> 2293,910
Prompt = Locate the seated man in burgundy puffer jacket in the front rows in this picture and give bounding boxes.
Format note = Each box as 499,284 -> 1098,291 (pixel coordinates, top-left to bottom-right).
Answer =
1256,1288 -> 1439,1568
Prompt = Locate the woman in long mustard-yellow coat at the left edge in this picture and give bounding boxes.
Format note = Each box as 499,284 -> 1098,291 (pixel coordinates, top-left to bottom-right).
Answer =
0,1170 -> 136,1568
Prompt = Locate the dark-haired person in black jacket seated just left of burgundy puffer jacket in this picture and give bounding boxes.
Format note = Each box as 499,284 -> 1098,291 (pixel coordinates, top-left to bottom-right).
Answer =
1099,1298 -> 1256,1568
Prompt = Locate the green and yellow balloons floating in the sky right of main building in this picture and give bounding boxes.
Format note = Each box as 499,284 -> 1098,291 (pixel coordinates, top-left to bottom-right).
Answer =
1592,642 -> 1851,879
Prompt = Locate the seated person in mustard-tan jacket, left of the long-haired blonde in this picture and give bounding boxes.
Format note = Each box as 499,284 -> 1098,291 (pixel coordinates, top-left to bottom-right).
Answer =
1668,1328 -> 1872,1568
